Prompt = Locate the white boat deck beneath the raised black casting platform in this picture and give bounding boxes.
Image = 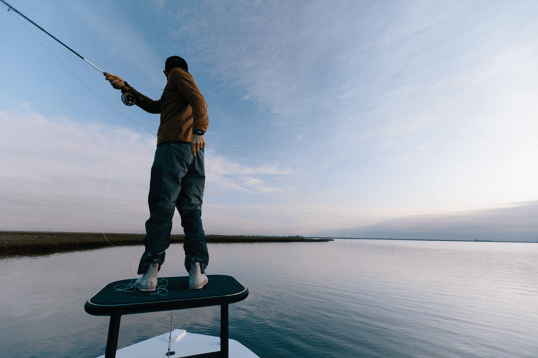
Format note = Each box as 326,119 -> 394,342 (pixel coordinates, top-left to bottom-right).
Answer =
98,329 -> 259,358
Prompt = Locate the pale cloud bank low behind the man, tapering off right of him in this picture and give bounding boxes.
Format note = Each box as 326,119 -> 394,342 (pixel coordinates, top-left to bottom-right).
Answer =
0,104 -> 294,233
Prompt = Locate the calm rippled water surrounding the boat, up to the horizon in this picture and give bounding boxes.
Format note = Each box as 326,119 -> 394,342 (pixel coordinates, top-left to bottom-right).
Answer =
0,240 -> 538,358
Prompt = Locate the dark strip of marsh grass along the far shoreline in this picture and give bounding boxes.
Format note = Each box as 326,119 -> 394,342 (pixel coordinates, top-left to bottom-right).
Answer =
0,231 -> 333,257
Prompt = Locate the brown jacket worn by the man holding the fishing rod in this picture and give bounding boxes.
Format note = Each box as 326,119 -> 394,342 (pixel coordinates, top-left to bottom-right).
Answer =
122,67 -> 209,145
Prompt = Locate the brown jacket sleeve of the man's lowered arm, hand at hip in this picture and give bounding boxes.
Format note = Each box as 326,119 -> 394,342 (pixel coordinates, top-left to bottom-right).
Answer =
170,68 -> 209,133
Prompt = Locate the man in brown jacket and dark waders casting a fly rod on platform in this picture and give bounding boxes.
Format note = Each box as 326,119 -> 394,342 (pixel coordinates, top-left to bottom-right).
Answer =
105,56 -> 209,291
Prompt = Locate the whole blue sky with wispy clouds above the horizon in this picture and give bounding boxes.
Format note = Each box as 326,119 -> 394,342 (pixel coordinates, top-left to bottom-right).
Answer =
0,0 -> 538,240
